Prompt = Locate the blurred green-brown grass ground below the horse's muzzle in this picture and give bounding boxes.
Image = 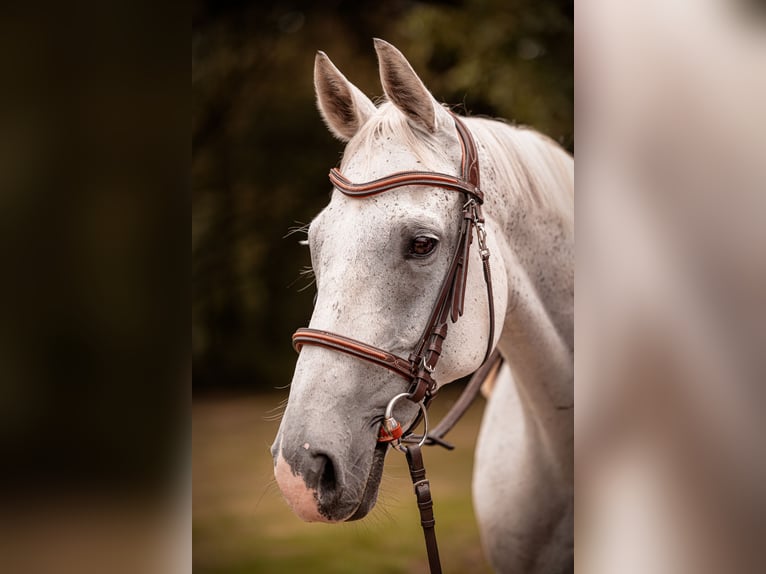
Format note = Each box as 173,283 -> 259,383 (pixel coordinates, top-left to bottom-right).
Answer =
192,387 -> 490,574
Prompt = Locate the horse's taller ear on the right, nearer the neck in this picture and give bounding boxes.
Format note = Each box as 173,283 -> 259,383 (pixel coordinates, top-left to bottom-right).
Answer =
375,38 -> 443,133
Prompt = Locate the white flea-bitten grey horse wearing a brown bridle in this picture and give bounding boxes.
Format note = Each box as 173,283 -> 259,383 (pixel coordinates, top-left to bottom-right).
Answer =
271,39 -> 574,574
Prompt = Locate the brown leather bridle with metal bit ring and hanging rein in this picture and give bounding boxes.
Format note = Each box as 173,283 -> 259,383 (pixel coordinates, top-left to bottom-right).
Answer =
292,115 -> 502,574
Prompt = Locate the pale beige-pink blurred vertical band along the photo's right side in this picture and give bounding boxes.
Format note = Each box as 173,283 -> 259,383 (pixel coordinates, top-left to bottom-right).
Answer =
575,0 -> 766,574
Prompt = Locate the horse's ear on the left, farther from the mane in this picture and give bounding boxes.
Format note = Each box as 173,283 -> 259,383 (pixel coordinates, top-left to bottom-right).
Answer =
314,52 -> 375,142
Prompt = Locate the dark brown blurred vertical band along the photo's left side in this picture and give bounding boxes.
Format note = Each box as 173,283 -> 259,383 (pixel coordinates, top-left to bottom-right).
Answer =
0,0 -> 191,574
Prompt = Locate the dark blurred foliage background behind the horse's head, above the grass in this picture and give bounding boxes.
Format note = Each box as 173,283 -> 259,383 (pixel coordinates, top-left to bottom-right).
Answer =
191,0 -> 574,394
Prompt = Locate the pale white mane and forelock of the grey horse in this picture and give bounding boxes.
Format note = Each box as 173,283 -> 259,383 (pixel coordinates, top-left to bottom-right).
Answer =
341,102 -> 574,226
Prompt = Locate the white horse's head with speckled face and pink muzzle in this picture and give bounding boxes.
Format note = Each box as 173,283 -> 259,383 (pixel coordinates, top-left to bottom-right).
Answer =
272,40 -> 506,522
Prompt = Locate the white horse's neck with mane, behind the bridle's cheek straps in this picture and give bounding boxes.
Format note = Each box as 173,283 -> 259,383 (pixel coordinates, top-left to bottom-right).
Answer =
474,121 -> 574,448
